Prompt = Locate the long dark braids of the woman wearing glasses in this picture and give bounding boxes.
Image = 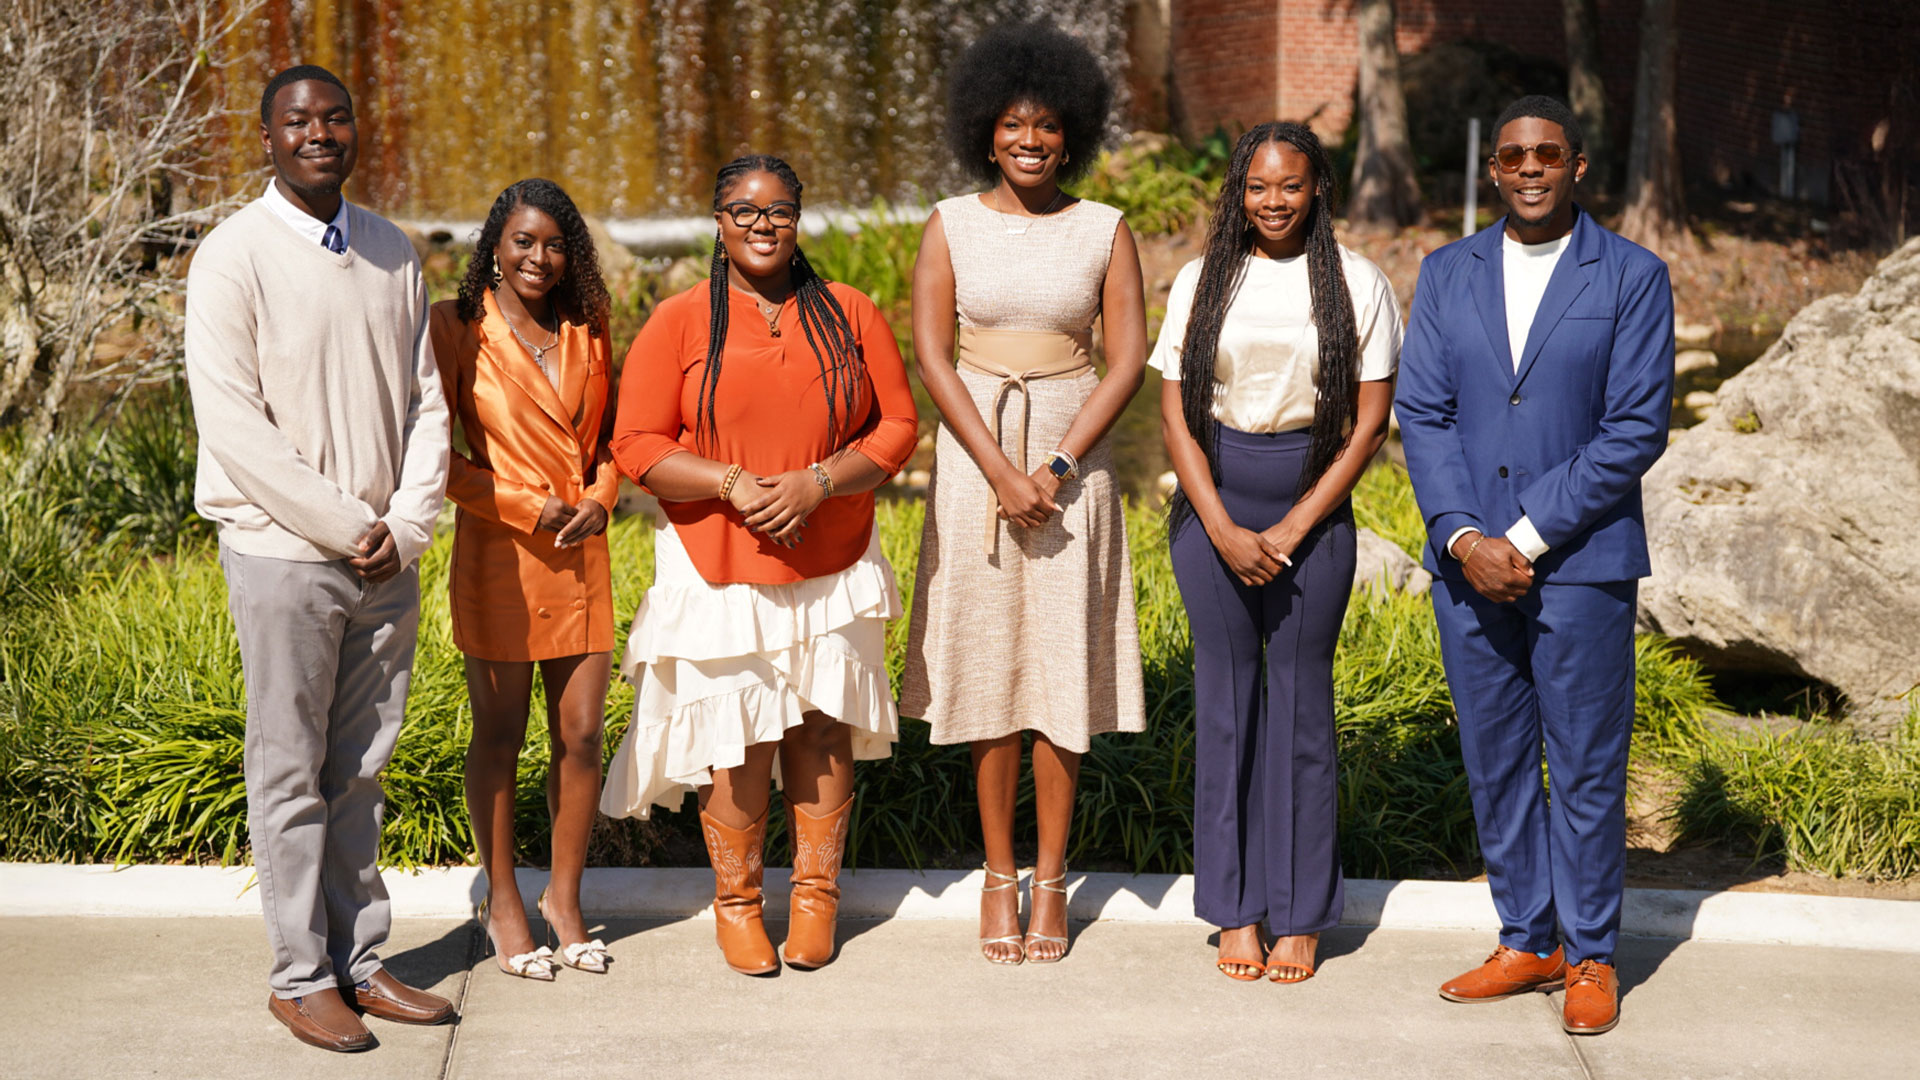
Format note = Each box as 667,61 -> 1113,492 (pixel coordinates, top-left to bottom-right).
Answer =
693,154 -> 866,448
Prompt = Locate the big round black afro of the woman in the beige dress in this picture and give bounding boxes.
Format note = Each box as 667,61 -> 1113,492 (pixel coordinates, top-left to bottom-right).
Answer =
947,19 -> 1114,183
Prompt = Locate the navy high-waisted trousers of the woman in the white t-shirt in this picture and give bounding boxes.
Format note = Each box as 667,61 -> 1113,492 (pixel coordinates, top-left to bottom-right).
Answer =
1173,429 -> 1354,934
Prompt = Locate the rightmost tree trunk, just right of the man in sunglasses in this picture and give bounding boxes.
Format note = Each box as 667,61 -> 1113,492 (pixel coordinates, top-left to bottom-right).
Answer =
1620,0 -> 1693,254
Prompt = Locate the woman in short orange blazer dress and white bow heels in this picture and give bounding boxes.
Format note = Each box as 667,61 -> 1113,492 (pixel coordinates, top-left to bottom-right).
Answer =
430,179 -> 620,980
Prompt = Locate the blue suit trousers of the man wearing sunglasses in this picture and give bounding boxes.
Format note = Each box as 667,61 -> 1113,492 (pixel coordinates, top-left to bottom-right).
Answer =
1432,580 -> 1640,963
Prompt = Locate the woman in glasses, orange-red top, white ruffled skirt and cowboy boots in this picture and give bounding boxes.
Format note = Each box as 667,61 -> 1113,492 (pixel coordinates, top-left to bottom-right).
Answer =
601,156 -> 918,974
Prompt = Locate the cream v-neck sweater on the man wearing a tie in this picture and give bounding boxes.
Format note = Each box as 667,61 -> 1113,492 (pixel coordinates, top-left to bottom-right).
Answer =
186,200 -> 447,565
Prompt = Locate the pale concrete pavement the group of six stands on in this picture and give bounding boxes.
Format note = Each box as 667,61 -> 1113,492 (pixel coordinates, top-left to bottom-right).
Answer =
0,917 -> 1920,1080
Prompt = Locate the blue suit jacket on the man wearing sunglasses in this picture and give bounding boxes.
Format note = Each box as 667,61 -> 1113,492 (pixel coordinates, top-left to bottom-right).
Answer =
1394,208 -> 1674,582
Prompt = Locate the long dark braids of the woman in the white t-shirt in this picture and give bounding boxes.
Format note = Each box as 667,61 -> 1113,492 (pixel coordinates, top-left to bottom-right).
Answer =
1167,121 -> 1359,530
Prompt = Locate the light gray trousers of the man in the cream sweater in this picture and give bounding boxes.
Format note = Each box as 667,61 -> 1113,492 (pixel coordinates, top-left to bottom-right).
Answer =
221,544 -> 420,997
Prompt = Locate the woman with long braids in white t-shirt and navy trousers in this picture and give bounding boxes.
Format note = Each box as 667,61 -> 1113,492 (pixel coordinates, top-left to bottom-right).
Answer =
1148,123 -> 1402,982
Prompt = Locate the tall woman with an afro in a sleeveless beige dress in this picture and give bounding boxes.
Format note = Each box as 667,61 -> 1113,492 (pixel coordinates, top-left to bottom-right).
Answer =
900,21 -> 1146,965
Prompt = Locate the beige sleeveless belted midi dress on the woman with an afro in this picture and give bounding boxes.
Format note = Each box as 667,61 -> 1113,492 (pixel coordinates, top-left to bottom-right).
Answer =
900,194 -> 1146,753
